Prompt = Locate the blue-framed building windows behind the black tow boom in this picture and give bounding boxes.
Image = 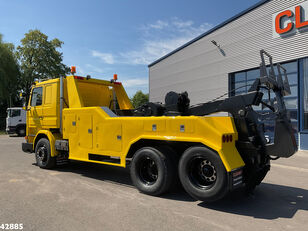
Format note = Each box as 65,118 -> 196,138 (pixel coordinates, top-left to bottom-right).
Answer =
230,59 -> 298,137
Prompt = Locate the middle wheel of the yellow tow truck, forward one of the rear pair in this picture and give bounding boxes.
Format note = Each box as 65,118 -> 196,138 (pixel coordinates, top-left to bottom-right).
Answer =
130,147 -> 177,196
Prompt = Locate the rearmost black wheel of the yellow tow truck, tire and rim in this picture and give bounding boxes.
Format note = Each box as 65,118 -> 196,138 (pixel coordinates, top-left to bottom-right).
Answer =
179,147 -> 229,202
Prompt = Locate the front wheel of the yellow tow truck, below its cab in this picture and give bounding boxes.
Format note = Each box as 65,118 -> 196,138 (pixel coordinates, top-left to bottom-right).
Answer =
35,138 -> 56,169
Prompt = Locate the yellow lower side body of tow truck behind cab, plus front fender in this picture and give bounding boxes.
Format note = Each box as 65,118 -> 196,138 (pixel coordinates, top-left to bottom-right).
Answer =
33,111 -> 245,172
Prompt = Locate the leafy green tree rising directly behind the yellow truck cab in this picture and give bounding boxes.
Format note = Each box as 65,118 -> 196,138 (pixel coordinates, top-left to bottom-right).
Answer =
17,30 -> 69,102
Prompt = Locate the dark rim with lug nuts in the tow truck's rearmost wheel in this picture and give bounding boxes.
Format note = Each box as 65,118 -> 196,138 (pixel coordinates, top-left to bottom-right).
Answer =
188,156 -> 217,189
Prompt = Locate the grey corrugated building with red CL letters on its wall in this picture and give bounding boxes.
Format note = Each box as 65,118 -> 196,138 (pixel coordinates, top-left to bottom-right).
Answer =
149,0 -> 308,149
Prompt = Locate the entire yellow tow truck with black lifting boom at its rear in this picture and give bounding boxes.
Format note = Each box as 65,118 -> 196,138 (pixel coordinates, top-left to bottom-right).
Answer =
22,51 -> 297,202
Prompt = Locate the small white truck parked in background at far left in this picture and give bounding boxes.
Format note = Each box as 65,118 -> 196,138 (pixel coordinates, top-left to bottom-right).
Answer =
6,107 -> 26,136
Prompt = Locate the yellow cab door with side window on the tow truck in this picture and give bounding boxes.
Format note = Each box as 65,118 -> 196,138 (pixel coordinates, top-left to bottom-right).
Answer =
28,87 -> 43,137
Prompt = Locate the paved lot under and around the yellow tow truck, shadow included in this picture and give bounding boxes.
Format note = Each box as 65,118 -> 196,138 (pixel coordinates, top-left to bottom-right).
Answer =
0,135 -> 308,231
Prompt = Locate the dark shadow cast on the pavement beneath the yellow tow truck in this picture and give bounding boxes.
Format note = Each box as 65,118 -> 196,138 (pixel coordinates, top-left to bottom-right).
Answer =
42,161 -> 308,208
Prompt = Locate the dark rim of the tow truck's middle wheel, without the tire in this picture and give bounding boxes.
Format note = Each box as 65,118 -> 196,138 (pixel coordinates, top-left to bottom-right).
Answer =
138,156 -> 158,185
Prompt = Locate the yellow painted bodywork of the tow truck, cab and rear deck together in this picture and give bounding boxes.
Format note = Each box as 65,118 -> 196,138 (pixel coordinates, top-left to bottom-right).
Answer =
27,76 -> 244,172
